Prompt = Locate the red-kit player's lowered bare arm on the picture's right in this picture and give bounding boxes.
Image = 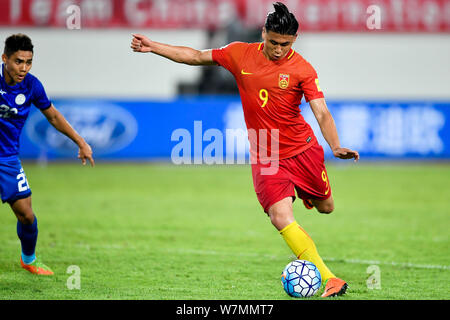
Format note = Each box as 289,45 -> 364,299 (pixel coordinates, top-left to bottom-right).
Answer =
309,98 -> 359,162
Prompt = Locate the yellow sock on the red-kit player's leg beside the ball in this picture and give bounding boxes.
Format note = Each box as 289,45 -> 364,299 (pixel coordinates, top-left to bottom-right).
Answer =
280,221 -> 336,283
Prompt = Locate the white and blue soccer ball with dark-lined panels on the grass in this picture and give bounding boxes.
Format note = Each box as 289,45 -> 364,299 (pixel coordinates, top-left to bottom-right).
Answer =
281,260 -> 322,298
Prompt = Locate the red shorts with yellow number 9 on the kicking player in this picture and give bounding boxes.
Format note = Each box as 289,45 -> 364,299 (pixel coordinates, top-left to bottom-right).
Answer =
252,143 -> 331,213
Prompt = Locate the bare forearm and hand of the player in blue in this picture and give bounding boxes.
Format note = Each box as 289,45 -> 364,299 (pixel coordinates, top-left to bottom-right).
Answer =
42,104 -> 95,167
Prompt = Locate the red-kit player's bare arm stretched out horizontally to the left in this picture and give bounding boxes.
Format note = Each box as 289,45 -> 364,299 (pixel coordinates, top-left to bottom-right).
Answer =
131,34 -> 216,66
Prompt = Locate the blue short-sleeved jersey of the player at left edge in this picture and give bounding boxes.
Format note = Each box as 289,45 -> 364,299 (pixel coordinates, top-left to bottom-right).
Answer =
0,64 -> 51,158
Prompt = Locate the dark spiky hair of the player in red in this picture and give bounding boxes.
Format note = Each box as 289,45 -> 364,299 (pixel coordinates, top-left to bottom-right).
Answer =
264,2 -> 298,36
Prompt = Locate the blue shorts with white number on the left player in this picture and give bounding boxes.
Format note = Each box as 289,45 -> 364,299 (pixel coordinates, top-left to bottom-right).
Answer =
0,156 -> 31,204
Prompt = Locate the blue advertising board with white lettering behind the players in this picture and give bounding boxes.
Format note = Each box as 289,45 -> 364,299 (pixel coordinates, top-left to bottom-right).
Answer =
20,96 -> 450,163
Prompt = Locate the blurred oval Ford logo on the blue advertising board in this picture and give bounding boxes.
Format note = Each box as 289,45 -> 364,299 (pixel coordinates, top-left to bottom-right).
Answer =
25,102 -> 138,155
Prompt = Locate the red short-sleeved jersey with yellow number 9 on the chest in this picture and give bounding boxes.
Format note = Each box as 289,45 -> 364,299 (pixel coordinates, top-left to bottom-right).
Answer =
212,42 -> 324,160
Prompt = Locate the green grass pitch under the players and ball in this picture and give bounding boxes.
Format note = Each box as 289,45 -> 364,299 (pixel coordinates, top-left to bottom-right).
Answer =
0,162 -> 450,300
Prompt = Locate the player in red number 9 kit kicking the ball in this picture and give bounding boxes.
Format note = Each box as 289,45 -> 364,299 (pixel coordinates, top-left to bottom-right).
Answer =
131,2 -> 359,297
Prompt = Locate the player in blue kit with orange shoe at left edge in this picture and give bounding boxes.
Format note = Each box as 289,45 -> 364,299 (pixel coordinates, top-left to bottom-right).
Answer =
0,34 -> 94,275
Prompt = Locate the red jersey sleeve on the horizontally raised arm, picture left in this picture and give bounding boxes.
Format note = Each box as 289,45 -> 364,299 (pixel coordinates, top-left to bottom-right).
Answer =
212,42 -> 248,74
